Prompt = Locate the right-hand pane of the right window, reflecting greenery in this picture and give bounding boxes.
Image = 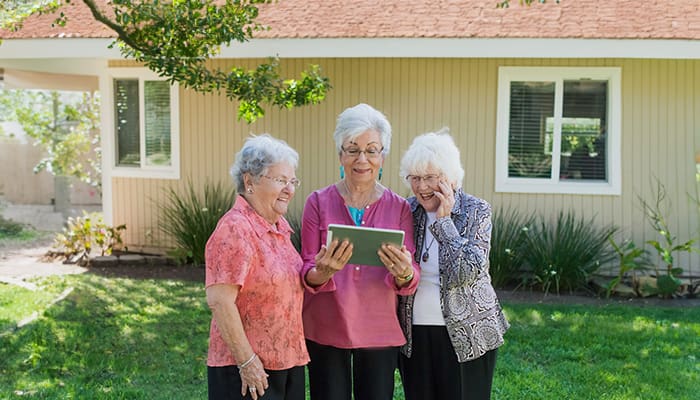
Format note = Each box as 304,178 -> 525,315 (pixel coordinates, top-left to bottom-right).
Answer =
560,80 -> 608,181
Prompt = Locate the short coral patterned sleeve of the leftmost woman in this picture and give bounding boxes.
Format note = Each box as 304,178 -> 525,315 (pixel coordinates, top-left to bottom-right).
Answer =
204,216 -> 254,287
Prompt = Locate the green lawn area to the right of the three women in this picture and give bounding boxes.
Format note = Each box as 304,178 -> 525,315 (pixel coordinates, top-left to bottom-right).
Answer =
494,304 -> 700,400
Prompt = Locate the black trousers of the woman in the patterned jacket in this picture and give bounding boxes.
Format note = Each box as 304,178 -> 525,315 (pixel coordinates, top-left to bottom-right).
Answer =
399,325 -> 496,400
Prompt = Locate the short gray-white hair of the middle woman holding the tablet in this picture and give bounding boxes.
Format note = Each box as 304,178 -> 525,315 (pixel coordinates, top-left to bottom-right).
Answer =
333,103 -> 391,156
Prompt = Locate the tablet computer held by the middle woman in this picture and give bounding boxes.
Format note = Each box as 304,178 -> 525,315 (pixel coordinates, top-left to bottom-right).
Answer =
326,224 -> 404,267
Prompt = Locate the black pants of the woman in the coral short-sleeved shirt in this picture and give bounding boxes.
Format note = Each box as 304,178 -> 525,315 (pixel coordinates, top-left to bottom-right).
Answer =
207,365 -> 305,400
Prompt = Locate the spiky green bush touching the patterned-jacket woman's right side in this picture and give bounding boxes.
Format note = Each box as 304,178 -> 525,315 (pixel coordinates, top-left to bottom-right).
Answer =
489,208 -> 535,287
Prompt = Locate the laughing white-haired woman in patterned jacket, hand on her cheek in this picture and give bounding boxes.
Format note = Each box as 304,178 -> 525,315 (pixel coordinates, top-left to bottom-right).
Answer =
399,129 -> 509,400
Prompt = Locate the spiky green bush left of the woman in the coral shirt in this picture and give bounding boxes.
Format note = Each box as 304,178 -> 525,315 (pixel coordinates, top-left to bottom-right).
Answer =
158,182 -> 236,265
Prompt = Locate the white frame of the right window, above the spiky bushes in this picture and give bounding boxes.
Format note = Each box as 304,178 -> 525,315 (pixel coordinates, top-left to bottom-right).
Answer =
495,67 -> 622,195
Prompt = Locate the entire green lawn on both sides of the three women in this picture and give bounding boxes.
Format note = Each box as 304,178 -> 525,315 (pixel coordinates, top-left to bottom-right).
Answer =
0,274 -> 700,400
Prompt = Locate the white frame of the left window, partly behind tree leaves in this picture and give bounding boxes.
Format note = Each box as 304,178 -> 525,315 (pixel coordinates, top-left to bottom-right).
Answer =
103,68 -> 180,179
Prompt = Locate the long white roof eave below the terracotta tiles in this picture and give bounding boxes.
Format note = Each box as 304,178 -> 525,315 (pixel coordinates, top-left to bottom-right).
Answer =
0,38 -> 700,59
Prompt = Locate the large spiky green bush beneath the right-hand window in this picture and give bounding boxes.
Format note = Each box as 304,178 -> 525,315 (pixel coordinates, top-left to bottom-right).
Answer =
524,211 -> 617,294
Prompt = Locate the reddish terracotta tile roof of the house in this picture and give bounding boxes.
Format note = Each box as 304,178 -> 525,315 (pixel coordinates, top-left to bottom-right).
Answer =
0,0 -> 700,39
